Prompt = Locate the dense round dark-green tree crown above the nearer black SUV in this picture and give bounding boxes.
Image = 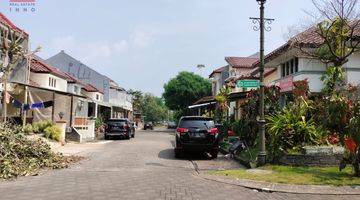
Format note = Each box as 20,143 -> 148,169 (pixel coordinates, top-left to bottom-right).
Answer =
163,72 -> 211,112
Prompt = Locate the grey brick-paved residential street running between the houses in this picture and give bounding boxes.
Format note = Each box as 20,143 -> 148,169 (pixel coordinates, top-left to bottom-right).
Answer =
0,131 -> 354,200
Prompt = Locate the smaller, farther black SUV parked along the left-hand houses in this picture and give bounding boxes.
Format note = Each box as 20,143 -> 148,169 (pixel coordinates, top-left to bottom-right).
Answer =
105,119 -> 135,140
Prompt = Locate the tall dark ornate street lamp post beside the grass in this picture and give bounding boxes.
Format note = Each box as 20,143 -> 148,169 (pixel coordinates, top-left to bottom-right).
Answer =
250,0 -> 274,166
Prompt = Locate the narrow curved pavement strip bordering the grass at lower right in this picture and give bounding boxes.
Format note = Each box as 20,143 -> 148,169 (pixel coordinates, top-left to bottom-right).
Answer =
197,171 -> 360,195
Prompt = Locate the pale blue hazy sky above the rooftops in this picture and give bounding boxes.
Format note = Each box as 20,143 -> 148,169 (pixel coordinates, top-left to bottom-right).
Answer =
0,0 -> 314,96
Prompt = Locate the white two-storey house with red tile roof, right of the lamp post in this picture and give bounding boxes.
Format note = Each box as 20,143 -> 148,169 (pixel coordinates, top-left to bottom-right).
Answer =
254,22 -> 360,93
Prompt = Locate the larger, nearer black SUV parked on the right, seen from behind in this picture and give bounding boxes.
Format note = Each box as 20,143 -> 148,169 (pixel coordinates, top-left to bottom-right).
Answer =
175,117 -> 220,158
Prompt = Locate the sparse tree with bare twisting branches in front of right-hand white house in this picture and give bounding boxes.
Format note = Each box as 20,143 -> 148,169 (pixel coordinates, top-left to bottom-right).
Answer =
295,0 -> 360,95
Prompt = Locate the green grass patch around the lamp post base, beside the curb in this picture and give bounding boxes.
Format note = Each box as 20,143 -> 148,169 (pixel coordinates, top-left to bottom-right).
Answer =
209,165 -> 360,186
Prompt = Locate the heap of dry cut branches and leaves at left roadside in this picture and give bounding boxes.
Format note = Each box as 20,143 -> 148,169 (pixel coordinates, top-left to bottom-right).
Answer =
0,124 -> 80,179
